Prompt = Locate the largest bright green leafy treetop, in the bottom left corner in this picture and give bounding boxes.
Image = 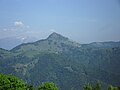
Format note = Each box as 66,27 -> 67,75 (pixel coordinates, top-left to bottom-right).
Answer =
0,74 -> 27,90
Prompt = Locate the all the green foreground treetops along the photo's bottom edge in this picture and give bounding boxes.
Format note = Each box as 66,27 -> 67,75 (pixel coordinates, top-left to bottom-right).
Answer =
0,74 -> 120,90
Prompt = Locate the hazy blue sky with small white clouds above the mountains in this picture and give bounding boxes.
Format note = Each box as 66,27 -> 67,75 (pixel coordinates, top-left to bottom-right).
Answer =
0,0 -> 120,43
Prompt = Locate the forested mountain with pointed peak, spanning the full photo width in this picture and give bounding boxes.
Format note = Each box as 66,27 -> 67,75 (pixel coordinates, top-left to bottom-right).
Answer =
0,32 -> 120,90
